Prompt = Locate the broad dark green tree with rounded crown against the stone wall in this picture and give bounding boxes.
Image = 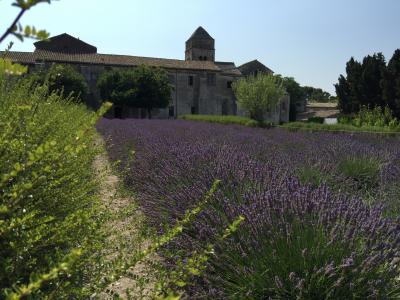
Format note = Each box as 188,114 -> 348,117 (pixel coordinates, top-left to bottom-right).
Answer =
97,65 -> 173,118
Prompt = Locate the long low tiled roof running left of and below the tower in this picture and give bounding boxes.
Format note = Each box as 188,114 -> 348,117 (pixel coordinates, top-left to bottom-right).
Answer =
0,50 -> 220,72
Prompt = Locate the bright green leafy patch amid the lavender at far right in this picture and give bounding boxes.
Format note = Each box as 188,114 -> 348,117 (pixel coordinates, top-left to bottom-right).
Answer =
337,157 -> 381,189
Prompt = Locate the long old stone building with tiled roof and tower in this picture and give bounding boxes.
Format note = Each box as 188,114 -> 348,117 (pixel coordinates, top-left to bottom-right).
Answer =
6,27 -> 290,123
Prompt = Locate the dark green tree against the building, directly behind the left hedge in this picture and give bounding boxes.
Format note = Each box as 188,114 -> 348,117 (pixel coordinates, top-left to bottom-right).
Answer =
30,64 -> 89,101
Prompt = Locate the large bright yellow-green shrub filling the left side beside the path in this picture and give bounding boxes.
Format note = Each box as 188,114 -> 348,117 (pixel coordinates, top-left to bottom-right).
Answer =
0,76 -> 106,298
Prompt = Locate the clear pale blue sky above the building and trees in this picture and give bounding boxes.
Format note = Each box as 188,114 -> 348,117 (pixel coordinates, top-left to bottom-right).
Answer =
0,0 -> 400,94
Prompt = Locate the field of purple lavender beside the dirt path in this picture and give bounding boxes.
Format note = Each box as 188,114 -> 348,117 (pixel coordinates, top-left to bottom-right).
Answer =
98,120 -> 400,299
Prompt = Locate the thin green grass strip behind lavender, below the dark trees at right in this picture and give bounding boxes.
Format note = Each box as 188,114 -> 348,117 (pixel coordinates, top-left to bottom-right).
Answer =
279,122 -> 400,134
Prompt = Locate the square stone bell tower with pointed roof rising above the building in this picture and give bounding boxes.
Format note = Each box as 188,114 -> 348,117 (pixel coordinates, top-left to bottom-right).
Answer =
185,26 -> 215,61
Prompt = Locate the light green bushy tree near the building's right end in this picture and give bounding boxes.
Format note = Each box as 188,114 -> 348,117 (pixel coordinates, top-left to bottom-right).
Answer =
232,74 -> 285,122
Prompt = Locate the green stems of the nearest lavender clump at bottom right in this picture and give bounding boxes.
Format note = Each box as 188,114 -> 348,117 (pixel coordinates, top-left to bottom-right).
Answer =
212,219 -> 379,299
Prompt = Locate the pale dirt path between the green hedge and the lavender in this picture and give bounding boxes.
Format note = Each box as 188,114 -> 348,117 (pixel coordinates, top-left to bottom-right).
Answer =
91,140 -> 160,300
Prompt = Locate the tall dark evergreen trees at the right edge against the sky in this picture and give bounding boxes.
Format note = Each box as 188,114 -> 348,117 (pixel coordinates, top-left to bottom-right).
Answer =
335,49 -> 400,118
